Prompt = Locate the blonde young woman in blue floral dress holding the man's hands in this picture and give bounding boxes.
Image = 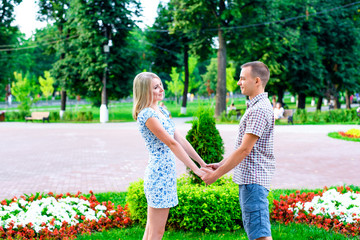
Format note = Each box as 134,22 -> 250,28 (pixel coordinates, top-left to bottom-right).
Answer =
133,72 -> 206,240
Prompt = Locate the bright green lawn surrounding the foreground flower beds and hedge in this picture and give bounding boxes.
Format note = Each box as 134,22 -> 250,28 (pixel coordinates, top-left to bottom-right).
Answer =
73,188 -> 360,240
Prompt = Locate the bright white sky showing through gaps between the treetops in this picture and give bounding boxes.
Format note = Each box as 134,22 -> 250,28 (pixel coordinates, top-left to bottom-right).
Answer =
12,0 -> 168,38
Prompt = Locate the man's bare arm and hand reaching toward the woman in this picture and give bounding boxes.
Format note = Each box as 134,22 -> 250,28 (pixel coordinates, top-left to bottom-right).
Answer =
201,133 -> 259,184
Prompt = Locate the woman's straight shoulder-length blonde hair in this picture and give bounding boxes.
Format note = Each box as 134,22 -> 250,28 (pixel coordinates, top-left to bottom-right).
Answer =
132,72 -> 160,120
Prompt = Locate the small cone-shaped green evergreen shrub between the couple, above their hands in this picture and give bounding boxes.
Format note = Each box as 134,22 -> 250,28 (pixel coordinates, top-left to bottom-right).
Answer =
186,107 -> 224,183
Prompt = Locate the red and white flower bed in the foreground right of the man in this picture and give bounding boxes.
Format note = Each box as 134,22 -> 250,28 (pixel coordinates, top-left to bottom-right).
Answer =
271,187 -> 360,236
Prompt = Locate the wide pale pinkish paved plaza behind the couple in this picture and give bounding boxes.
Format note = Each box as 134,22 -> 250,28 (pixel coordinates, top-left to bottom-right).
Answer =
0,119 -> 360,200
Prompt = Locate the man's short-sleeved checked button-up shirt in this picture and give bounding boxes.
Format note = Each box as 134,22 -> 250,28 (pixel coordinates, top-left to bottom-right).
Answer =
233,93 -> 275,190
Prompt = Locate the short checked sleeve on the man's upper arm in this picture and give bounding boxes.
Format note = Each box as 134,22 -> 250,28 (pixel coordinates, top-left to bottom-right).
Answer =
245,108 -> 268,137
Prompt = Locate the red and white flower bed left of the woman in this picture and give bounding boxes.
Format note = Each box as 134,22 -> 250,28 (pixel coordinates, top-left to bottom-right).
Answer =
0,191 -> 131,239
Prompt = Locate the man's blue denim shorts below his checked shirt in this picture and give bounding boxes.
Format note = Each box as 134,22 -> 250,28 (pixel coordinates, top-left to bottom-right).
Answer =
239,184 -> 271,240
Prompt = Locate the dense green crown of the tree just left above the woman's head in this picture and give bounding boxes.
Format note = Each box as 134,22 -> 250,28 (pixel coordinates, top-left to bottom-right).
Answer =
62,0 -> 140,108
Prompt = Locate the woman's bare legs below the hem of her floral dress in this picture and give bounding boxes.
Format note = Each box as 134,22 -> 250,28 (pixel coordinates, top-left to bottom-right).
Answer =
143,206 -> 169,240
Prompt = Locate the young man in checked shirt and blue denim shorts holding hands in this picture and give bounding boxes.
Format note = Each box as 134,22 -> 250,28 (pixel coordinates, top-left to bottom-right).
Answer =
202,62 -> 275,240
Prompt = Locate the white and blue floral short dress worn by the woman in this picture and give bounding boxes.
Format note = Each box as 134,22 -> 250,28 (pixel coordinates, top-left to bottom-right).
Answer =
137,107 -> 178,208
